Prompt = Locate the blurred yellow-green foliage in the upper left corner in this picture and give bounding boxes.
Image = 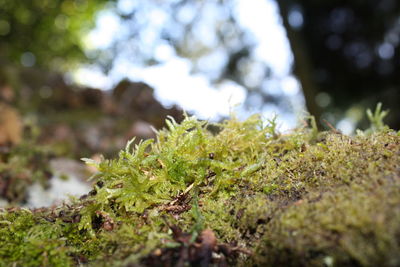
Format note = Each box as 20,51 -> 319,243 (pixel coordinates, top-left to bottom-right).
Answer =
0,0 -> 109,69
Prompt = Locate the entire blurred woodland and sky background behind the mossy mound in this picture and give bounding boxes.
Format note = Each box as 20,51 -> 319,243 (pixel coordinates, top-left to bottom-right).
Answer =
0,0 -> 400,207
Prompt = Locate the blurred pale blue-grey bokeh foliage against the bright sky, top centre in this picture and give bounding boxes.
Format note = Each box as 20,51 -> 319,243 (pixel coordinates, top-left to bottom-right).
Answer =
88,0 -> 293,112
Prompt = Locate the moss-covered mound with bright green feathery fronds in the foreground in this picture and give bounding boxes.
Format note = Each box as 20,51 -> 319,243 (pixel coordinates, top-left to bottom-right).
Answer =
0,112 -> 400,266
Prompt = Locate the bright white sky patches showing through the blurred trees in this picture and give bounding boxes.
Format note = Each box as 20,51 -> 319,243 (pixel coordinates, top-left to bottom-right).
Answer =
73,0 -> 304,130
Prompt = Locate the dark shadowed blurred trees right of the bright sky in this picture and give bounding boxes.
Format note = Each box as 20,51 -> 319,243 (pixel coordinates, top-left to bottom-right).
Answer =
277,0 -> 400,128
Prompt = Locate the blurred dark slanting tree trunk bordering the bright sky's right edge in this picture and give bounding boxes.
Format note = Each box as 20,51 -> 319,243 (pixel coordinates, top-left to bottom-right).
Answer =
276,0 -> 321,126
